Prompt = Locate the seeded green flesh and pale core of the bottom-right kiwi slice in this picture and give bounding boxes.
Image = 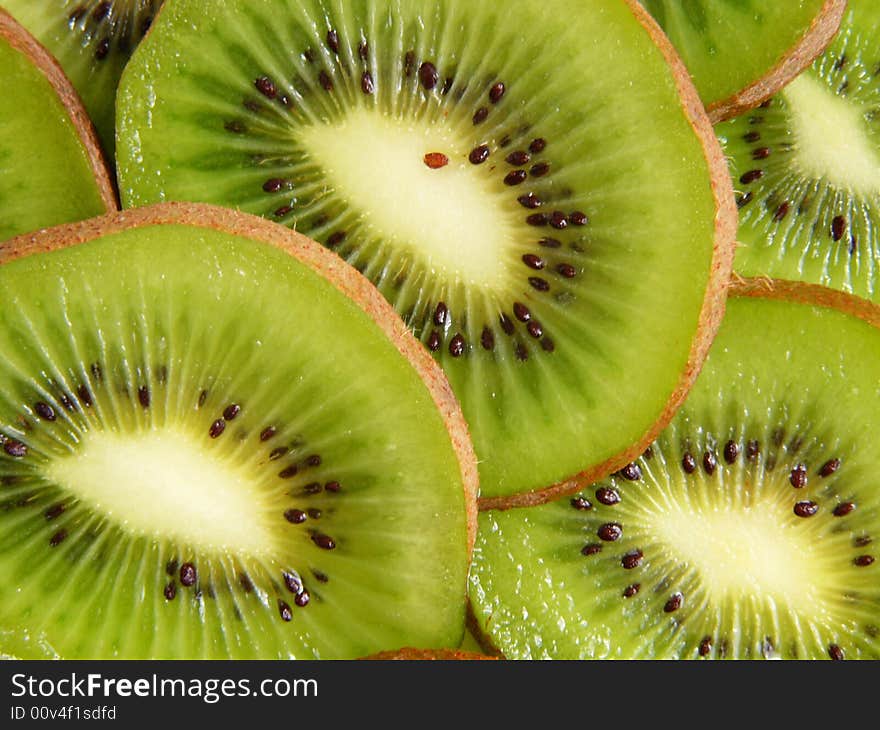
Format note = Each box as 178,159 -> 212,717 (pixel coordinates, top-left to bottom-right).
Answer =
471,292 -> 880,659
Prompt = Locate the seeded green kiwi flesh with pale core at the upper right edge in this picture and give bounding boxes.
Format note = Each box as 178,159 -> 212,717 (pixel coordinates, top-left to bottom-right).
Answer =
717,0 -> 880,301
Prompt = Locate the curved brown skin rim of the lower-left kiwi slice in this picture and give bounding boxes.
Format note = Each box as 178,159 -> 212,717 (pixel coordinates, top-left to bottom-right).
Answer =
0,203 -> 479,561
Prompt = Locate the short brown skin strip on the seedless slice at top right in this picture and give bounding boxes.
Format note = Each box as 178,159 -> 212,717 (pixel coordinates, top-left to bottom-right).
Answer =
707,0 -> 847,124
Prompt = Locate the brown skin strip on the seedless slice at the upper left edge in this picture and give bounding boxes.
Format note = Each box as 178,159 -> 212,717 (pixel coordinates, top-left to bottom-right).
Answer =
0,7 -> 119,213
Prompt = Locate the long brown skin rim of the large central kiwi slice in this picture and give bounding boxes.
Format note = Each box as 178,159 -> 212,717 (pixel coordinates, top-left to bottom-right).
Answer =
479,0 -> 739,511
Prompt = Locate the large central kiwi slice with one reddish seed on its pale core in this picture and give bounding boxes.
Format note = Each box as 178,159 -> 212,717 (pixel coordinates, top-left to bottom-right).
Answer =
118,0 -> 735,499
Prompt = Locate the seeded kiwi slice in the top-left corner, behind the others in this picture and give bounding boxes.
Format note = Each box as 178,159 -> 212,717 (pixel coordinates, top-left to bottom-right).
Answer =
3,0 -> 162,157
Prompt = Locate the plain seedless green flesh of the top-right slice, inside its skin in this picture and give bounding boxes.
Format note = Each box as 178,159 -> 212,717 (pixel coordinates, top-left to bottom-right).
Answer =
641,0 -> 825,111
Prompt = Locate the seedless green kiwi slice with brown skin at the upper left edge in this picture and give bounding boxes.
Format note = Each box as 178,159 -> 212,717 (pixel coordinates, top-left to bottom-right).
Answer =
0,8 -> 116,241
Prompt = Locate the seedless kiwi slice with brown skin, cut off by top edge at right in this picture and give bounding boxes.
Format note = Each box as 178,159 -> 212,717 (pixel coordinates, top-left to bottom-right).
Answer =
642,0 -> 846,122
